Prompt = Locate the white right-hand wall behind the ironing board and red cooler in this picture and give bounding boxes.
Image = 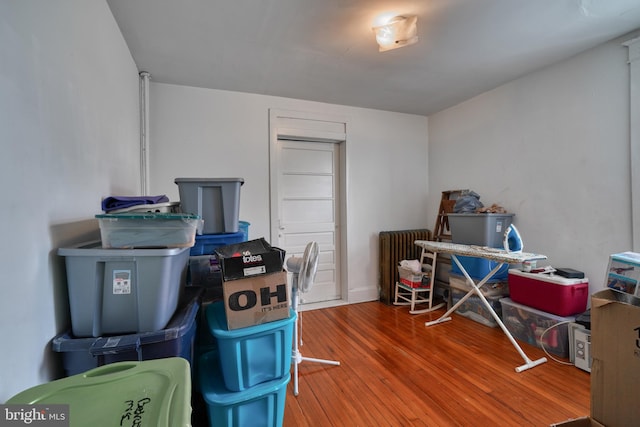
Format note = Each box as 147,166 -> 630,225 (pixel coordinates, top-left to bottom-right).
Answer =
428,31 -> 631,292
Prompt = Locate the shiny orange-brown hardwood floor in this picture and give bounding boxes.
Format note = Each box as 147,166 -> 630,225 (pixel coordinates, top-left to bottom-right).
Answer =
284,302 -> 590,427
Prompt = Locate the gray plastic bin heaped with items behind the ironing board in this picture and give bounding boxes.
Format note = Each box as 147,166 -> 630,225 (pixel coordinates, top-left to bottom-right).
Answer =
447,213 -> 515,248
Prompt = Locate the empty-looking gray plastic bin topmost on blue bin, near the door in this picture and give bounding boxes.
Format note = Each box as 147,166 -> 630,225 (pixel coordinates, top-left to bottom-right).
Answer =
175,178 -> 244,234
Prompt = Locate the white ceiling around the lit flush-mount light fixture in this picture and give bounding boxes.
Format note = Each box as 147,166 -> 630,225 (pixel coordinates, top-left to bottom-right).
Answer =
107,0 -> 640,115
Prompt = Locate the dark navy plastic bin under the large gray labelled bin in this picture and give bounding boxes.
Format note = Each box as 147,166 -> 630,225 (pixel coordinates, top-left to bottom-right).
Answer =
52,286 -> 203,376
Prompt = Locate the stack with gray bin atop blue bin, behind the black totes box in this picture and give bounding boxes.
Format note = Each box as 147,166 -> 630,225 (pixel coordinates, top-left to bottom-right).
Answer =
175,178 -> 250,301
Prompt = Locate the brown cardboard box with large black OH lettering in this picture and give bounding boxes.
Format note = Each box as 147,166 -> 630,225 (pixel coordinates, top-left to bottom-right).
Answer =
222,269 -> 290,330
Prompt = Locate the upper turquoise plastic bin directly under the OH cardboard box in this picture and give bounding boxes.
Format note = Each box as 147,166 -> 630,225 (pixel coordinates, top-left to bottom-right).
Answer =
205,301 -> 296,391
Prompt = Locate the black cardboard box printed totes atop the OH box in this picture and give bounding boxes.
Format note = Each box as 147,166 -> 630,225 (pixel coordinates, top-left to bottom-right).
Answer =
215,238 -> 285,281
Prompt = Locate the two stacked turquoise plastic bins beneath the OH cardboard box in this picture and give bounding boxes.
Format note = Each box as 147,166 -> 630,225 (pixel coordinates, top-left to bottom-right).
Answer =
197,301 -> 296,427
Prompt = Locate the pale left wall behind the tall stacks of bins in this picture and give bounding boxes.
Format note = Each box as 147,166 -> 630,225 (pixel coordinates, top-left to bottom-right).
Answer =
0,0 -> 139,402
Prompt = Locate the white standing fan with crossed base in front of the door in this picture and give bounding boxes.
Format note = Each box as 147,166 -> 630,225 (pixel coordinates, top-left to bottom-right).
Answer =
287,242 -> 340,396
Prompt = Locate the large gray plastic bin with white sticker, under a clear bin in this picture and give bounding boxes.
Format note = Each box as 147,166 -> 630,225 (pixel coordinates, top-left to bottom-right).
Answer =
58,241 -> 190,337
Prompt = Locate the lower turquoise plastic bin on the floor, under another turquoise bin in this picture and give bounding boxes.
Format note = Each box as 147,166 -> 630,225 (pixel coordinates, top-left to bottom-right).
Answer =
199,352 -> 291,427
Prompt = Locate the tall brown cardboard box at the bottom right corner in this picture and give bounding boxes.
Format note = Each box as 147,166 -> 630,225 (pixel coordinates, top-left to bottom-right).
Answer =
591,289 -> 640,427
